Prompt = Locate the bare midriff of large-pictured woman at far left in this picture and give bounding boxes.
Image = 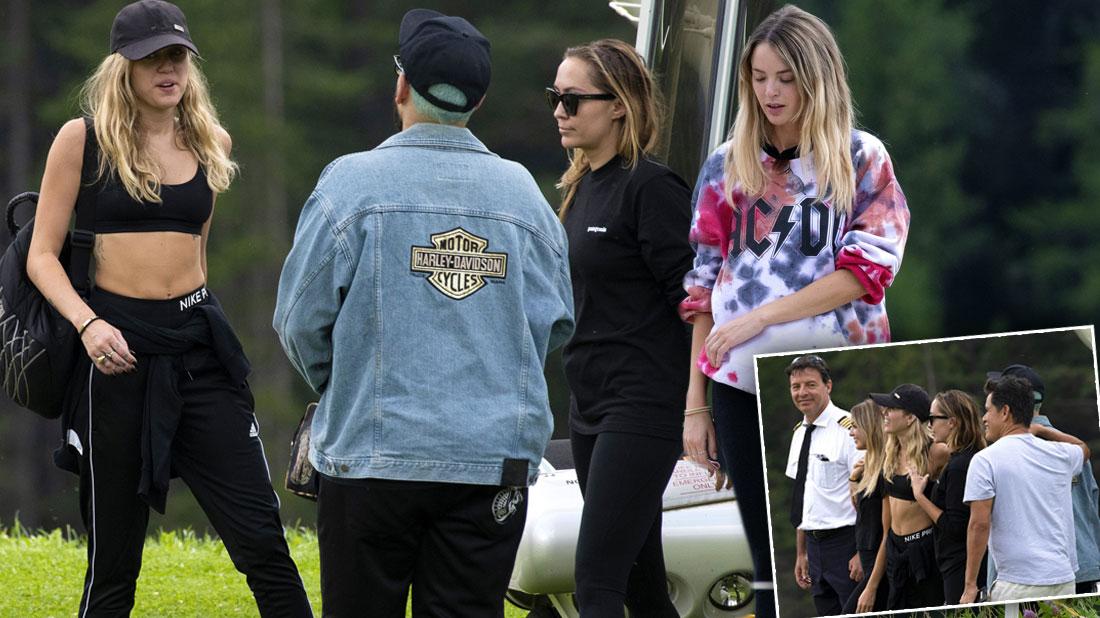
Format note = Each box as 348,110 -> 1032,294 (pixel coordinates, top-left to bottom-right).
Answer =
95,232 -> 206,300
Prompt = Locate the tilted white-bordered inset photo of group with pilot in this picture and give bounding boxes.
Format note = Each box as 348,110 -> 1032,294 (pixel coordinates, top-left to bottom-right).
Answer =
756,327 -> 1100,618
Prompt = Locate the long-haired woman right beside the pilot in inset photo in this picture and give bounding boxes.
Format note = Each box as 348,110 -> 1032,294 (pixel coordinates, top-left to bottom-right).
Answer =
844,399 -> 890,614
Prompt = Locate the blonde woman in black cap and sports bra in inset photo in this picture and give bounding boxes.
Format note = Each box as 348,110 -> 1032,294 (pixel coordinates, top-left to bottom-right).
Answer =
856,384 -> 949,613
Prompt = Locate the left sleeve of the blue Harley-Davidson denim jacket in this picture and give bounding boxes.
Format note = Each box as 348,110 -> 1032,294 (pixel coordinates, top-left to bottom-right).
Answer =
272,184 -> 352,395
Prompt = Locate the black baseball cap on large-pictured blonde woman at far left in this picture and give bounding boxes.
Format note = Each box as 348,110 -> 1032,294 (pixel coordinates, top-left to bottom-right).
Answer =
111,0 -> 199,60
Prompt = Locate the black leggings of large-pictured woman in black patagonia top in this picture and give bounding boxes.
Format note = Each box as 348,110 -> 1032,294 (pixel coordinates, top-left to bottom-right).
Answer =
570,431 -> 683,618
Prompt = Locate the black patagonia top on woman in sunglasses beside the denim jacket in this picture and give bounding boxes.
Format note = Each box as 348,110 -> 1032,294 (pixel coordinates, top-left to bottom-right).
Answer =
563,157 -> 694,440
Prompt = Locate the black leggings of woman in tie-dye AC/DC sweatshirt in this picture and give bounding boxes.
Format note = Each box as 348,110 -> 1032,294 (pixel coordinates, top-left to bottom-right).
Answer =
712,382 -> 774,618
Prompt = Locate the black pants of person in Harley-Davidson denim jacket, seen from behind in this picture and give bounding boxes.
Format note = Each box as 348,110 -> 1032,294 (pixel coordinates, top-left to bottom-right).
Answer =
317,475 -> 527,618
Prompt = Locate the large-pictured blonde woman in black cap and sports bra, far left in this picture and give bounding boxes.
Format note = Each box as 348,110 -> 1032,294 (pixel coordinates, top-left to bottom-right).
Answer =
26,0 -> 312,617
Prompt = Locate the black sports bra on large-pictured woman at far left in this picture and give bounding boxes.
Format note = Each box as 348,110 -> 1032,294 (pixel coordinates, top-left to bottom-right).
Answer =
85,123 -> 213,234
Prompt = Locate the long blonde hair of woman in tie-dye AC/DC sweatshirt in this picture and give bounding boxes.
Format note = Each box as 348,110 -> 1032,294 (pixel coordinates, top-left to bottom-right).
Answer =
725,4 -> 856,212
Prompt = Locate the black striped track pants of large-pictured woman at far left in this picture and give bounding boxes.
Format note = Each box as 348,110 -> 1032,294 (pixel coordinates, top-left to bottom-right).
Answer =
74,295 -> 312,618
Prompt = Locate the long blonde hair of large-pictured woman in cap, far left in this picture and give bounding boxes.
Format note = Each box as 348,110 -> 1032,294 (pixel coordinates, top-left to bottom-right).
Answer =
80,53 -> 237,203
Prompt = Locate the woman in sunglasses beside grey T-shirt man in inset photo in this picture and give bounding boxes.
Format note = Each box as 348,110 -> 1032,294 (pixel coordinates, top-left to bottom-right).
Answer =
910,390 -> 986,604
